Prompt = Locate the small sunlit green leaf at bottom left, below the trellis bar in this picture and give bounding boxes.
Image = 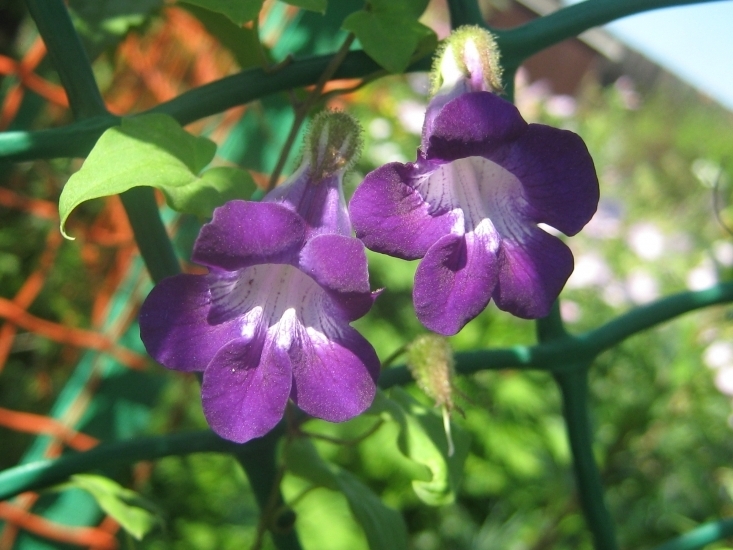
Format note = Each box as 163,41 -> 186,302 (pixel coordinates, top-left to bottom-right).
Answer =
71,474 -> 161,540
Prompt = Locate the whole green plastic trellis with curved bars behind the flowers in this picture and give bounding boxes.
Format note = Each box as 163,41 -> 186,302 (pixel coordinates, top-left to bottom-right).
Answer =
0,0 -> 733,550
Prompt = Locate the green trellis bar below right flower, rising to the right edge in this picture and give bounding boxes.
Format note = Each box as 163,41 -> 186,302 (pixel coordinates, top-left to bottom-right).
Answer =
379,282 -> 733,389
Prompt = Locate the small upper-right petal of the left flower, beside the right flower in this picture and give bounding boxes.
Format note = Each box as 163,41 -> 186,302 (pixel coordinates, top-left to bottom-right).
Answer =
300,234 -> 369,293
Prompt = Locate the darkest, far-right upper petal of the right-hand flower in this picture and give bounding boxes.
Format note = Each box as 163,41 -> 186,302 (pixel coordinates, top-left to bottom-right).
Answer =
499,124 -> 599,235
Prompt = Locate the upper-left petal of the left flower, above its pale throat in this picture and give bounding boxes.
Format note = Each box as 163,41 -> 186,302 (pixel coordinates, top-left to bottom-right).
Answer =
192,200 -> 305,271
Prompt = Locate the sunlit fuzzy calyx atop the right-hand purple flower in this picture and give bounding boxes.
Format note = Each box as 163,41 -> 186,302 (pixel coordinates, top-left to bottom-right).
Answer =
431,26 -> 502,95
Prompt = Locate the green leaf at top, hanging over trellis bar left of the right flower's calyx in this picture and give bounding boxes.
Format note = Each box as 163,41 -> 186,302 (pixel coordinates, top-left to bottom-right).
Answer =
342,10 -> 435,73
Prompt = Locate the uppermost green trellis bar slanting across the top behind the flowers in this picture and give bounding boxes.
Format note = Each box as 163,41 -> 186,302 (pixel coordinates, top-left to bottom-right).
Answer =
0,0 -> 721,161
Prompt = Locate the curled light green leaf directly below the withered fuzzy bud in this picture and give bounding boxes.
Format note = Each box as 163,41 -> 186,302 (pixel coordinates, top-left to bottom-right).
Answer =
368,388 -> 469,506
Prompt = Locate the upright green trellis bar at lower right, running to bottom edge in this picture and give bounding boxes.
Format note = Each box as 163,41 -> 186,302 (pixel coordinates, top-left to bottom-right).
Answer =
555,363 -> 618,550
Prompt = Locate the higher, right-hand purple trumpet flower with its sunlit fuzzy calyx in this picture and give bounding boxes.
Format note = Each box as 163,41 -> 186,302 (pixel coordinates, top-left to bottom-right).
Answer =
349,27 -> 599,335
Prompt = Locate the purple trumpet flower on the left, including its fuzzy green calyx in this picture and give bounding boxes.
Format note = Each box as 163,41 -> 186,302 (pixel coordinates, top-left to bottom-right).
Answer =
140,113 -> 379,443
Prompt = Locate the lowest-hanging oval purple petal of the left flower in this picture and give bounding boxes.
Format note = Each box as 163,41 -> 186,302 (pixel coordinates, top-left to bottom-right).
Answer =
201,330 -> 292,443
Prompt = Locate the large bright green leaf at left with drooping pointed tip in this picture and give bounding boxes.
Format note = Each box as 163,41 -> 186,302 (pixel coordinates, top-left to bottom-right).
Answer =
59,114 -> 254,236
